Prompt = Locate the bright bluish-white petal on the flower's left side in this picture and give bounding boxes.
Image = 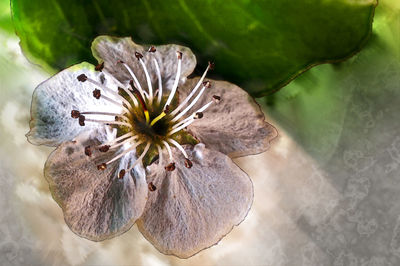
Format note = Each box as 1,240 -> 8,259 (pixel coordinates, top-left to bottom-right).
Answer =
27,63 -> 121,146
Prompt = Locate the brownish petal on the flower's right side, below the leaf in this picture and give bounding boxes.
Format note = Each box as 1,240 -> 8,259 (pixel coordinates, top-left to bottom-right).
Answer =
179,78 -> 278,158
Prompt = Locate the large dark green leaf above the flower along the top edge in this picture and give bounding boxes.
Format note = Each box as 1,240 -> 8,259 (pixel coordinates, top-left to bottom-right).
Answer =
11,0 -> 376,96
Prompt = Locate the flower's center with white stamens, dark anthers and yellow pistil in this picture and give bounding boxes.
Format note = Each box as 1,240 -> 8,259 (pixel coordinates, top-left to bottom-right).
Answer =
71,46 -> 220,178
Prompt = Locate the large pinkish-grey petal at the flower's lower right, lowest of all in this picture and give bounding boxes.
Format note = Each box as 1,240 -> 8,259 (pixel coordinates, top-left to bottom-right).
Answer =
137,144 -> 253,258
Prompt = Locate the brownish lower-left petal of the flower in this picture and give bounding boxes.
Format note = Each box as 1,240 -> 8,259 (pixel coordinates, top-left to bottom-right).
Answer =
44,132 -> 148,241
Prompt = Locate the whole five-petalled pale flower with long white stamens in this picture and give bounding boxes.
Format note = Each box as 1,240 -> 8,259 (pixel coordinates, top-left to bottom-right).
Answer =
27,36 -> 277,258
